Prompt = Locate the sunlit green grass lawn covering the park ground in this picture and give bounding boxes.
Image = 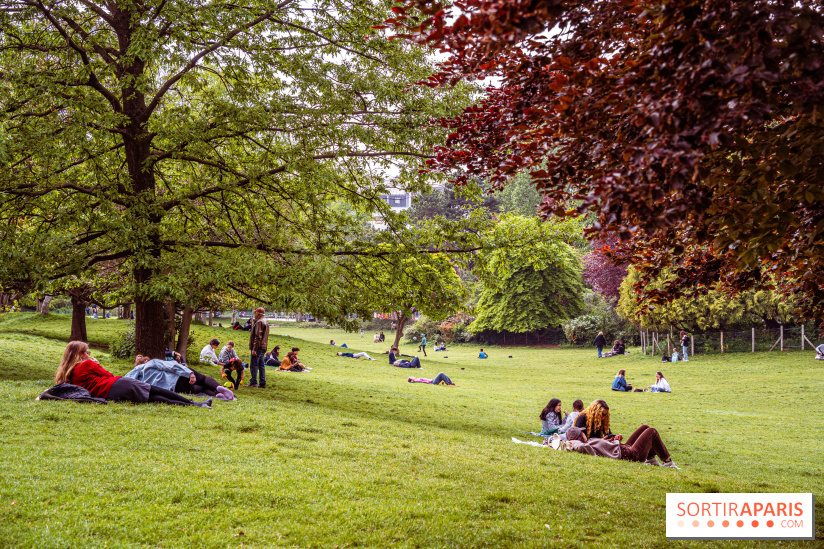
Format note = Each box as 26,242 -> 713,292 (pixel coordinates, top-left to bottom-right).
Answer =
0,314 -> 824,548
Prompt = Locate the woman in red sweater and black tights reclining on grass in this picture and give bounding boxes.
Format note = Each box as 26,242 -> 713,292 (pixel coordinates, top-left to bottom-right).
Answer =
54,341 -> 206,406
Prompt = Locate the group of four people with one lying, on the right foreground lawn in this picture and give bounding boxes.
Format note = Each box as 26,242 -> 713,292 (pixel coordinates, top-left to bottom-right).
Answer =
540,398 -> 680,469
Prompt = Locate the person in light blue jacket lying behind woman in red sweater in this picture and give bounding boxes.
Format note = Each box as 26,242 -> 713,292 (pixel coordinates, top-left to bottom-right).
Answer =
125,355 -> 235,400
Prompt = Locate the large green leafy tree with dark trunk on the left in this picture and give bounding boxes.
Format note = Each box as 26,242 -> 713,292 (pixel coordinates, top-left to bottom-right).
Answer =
0,0 -> 468,357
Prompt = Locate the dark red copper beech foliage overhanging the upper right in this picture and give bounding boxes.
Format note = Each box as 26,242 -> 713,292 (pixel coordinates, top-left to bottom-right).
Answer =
386,0 -> 824,318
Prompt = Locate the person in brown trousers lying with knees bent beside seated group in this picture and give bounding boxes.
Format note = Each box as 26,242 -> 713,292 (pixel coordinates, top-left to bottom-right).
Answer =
565,425 -> 680,469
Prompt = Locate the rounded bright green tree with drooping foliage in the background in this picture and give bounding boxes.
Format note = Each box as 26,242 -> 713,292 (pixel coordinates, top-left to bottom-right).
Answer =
470,215 -> 584,333
